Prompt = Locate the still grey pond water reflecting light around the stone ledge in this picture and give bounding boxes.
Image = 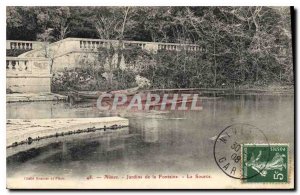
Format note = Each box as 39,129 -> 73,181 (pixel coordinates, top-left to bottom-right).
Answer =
7,95 -> 294,178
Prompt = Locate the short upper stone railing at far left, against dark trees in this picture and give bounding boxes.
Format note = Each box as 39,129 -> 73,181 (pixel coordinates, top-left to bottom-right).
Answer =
6,40 -> 44,50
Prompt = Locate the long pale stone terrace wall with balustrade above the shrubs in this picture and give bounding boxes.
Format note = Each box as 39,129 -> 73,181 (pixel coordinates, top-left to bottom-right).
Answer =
15,38 -> 203,71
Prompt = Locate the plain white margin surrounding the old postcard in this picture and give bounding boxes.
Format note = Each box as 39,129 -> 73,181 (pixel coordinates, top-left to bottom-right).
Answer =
0,0 -> 300,194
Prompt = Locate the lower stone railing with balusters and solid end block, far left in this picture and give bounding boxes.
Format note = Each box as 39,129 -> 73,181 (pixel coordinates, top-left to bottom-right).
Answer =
6,57 -> 50,75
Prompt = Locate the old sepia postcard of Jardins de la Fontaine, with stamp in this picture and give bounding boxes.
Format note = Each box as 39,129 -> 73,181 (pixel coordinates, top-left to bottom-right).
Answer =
6,6 -> 296,189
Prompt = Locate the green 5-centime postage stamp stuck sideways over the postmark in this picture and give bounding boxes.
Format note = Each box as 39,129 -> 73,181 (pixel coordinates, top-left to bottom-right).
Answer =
242,144 -> 289,183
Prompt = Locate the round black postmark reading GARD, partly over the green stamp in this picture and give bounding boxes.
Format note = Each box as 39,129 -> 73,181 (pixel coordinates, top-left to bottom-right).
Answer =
213,123 -> 270,180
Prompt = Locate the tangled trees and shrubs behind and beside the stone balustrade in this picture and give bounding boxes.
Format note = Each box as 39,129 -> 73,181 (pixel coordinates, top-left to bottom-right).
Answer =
6,6 -> 294,88
